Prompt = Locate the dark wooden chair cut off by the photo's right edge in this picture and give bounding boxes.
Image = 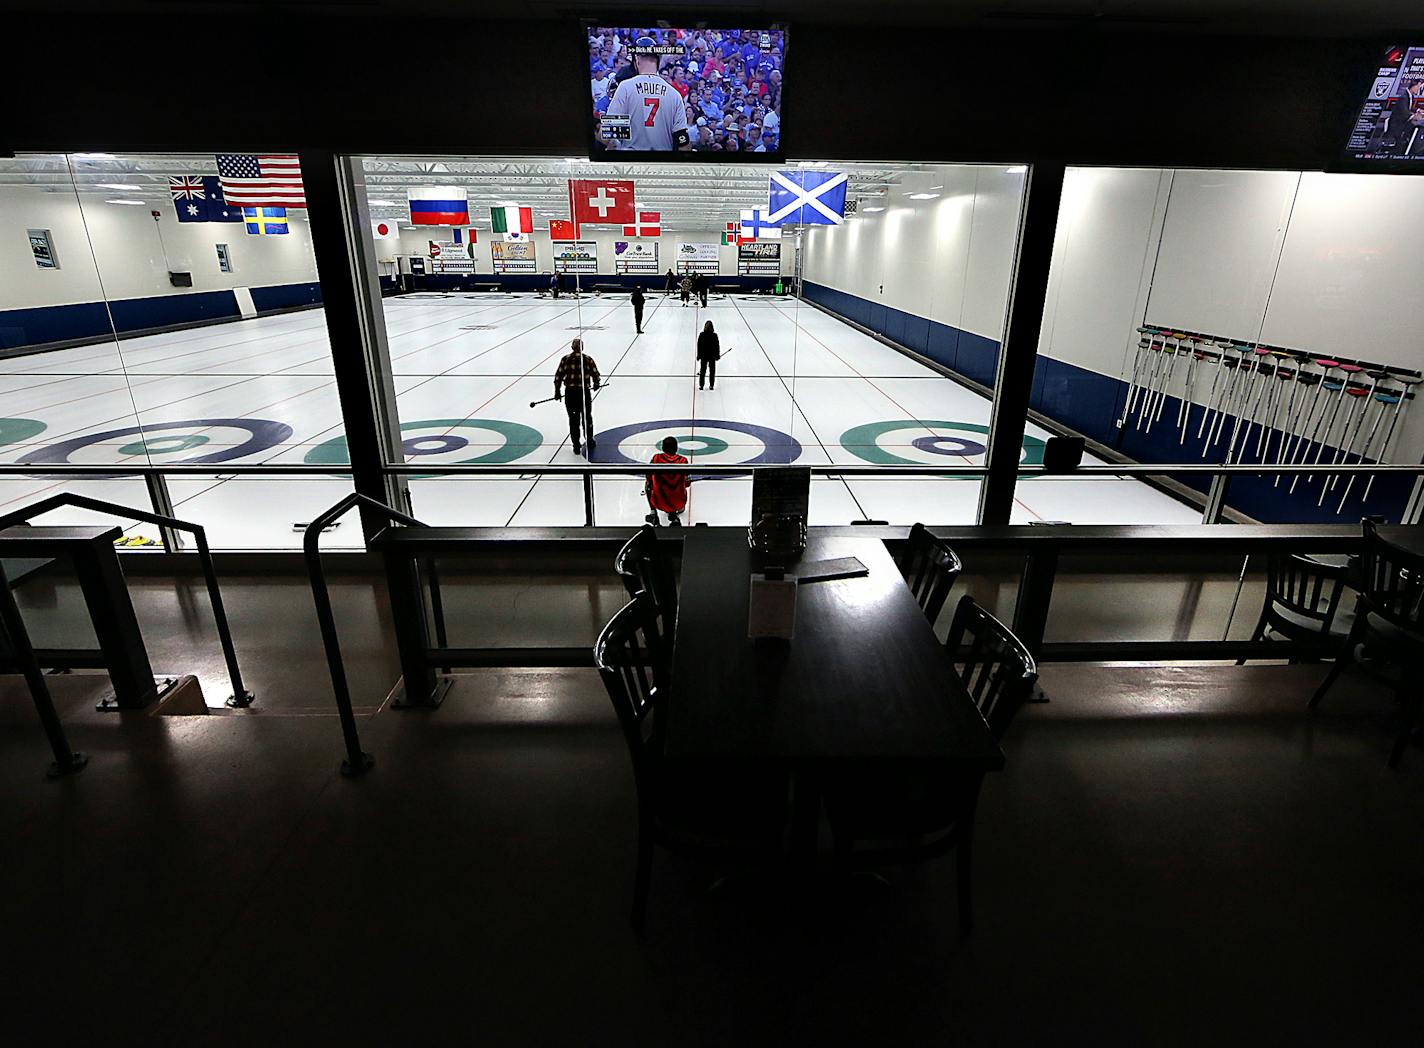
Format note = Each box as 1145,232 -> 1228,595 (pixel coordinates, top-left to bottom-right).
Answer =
1310,520 -> 1424,767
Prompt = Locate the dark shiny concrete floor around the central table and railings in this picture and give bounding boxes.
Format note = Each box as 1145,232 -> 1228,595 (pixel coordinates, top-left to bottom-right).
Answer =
0,577 -> 1424,1045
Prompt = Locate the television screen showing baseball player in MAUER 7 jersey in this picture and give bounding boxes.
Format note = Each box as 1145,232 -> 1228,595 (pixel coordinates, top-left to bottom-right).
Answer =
584,23 -> 787,162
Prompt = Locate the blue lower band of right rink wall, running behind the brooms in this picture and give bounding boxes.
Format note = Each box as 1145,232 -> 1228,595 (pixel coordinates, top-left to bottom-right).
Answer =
803,281 -> 1414,524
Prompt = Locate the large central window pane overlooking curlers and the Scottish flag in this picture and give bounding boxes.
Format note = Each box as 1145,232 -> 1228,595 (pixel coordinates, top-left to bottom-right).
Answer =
353,157 -> 1041,524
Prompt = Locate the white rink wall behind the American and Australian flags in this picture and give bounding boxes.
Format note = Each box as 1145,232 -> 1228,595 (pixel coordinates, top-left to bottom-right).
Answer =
0,185 -> 318,309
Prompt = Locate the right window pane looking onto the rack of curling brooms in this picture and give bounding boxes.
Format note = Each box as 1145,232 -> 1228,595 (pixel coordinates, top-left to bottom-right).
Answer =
1036,168 -> 1424,523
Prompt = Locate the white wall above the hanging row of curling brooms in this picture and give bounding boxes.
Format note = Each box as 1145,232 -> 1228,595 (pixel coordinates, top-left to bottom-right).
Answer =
1040,168 -> 1424,461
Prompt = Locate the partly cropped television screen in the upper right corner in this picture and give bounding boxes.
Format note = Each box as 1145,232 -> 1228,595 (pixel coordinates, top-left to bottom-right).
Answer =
1346,44 -> 1424,172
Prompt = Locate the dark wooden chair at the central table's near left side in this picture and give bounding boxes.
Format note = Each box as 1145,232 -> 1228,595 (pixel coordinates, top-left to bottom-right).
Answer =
594,592 -> 786,933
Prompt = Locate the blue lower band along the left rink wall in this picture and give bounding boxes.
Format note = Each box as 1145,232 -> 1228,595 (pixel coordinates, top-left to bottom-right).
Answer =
0,283 -> 322,349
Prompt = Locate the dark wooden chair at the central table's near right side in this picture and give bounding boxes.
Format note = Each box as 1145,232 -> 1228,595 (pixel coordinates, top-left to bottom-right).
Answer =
826,595 -> 1038,933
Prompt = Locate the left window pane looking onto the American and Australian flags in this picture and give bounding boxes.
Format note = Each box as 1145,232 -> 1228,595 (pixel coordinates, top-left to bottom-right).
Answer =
0,154 -> 349,548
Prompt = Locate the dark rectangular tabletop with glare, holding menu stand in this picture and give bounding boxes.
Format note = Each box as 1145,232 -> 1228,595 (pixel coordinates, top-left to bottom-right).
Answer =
666,528 -> 1004,769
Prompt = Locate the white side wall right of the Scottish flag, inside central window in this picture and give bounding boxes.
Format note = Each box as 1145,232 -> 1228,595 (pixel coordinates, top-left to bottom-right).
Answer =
802,165 -> 1025,340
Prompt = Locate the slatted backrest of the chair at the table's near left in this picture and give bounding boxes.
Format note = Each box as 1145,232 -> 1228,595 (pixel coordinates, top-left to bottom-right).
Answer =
594,592 -> 669,805
